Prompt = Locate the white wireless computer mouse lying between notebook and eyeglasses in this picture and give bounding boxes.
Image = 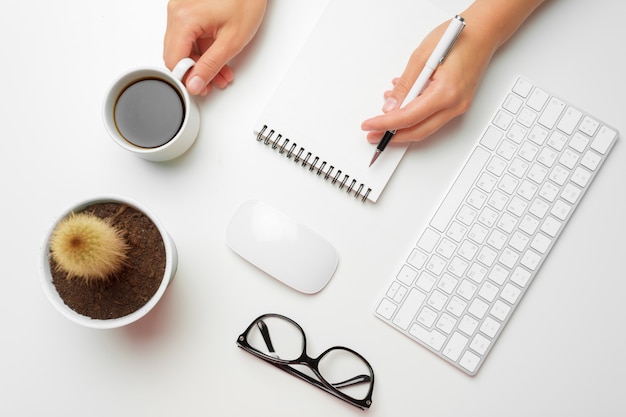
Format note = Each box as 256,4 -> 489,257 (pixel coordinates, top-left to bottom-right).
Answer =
226,201 -> 339,294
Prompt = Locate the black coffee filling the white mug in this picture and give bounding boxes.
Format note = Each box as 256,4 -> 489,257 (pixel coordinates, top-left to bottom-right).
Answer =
114,78 -> 185,148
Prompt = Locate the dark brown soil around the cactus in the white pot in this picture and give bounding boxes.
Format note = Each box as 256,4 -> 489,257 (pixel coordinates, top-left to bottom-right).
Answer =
50,203 -> 165,320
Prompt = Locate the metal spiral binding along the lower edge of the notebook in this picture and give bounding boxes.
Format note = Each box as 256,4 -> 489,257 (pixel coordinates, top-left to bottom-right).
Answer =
254,125 -> 372,202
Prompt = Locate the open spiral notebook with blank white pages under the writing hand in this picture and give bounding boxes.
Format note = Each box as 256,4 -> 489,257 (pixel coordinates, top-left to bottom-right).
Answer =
253,0 -> 451,202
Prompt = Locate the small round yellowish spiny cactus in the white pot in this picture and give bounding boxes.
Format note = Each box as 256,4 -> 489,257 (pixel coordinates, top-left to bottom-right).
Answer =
50,213 -> 128,282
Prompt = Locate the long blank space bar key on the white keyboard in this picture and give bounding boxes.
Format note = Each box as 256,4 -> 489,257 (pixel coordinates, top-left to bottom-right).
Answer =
430,146 -> 490,233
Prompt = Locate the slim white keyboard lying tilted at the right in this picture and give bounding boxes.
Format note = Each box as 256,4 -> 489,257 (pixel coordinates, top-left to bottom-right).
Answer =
375,78 -> 618,375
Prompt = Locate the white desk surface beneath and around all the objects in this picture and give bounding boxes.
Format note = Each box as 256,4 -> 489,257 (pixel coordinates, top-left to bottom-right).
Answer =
0,0 -> 626,416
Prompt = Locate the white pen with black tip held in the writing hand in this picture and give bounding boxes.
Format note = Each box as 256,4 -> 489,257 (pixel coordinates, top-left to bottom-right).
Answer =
370,15 -> 465,166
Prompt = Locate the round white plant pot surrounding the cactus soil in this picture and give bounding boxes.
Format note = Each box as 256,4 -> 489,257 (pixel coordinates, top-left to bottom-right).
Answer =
39,195 -> 178,329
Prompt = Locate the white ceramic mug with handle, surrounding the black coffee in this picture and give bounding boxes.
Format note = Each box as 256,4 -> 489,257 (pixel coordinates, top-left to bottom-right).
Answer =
103,58 -> 200,161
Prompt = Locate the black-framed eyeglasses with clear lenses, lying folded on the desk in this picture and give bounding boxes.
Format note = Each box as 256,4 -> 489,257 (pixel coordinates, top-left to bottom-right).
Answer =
237,314 -> 374,409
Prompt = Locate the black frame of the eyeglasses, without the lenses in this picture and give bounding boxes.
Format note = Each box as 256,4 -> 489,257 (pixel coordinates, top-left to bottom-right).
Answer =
237,313 -> 374,410
